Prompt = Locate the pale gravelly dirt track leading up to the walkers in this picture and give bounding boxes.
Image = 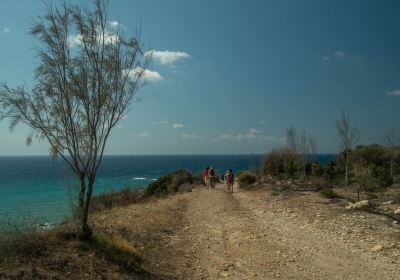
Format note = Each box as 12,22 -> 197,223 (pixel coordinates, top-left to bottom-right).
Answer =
167,185 -> 400,279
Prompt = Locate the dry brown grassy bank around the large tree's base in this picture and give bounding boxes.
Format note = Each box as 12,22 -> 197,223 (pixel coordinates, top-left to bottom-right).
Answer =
0,192 -> 189,279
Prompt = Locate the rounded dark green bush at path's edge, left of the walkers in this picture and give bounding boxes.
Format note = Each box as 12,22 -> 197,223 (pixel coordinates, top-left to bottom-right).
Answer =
145,170 -> 193,196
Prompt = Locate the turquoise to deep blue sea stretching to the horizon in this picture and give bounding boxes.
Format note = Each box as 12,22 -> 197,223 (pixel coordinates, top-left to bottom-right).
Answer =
0,154 -> 336,227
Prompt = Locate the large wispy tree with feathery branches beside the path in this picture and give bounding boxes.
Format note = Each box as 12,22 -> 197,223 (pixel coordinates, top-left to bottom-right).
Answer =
0,0 -> 150,238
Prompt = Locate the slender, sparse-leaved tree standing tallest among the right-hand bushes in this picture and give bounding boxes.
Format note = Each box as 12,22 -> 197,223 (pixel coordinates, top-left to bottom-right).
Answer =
336,113 -> 359,187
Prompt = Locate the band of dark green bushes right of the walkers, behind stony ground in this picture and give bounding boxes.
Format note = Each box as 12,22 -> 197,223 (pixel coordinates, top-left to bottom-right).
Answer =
261,144 -> 400,200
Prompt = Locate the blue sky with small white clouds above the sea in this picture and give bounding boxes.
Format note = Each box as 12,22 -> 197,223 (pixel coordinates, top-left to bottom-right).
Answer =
0,0 -> 400,156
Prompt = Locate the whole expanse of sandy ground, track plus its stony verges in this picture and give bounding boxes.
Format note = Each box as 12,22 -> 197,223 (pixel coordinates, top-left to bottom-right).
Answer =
94,184 -> 400,279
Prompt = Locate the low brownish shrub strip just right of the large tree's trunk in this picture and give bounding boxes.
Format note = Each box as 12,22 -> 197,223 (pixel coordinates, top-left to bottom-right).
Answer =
90,188 -> 141,212
